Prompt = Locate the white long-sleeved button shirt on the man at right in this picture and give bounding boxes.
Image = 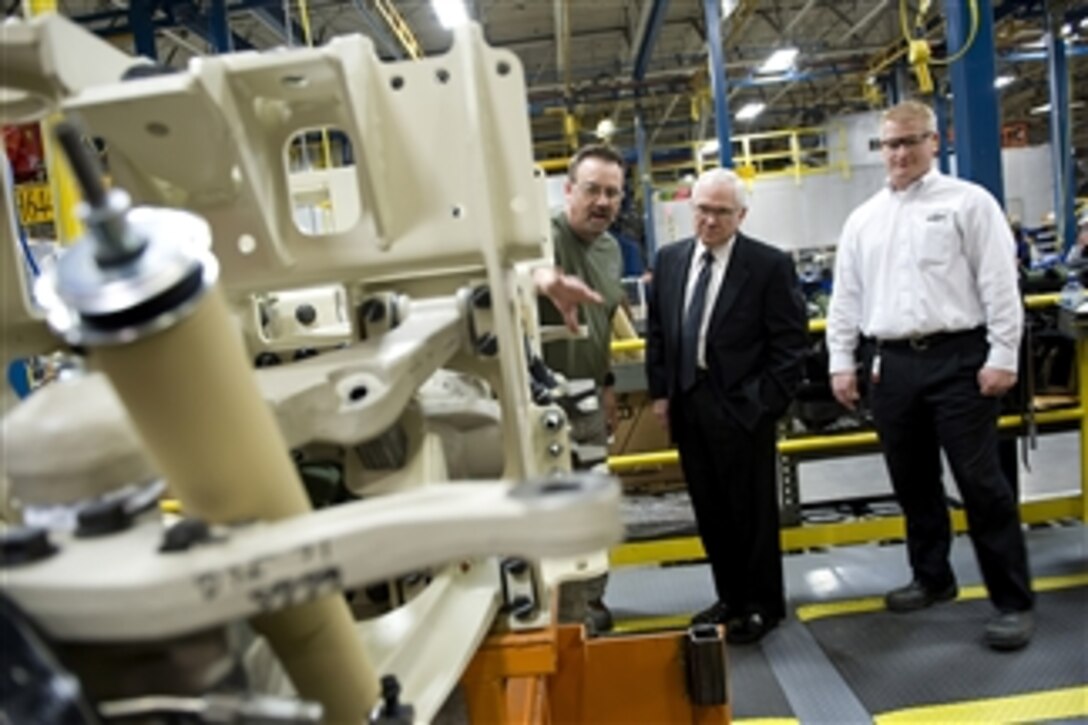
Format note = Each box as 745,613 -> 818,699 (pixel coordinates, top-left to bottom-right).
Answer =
827,170 -> 1024,373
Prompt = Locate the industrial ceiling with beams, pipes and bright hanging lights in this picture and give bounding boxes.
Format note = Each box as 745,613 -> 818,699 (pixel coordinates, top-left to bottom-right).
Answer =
34,0 -> 1088,175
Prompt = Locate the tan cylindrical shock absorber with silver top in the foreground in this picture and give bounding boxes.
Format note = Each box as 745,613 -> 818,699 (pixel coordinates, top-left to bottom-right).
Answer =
39,123 -> 379,723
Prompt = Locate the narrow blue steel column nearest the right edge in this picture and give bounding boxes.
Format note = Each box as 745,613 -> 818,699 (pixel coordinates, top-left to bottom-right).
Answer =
1047,9 -> 1077,250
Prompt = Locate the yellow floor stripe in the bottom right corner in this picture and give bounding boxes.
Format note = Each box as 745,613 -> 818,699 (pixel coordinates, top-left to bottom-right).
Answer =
874,687 -> 1088,725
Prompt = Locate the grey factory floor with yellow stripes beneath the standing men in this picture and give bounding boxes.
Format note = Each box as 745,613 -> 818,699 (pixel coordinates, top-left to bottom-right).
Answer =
605,432 -> 1088,723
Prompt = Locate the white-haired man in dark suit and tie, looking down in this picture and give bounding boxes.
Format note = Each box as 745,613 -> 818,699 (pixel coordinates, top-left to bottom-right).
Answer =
646,169 -> 807,644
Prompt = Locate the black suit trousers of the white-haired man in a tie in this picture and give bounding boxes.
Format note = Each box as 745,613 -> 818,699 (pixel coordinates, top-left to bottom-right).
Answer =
670,380 -> 786,619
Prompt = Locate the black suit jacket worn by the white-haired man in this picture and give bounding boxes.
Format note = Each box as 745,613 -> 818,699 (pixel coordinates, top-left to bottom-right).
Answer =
646,233 -> 807,430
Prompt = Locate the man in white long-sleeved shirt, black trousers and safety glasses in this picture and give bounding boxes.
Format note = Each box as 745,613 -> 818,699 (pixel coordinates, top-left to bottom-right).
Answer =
827,101 -> 1035,650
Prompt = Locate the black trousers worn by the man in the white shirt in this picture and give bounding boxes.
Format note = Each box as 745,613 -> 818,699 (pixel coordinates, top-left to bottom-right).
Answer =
864,333 -> 1034,612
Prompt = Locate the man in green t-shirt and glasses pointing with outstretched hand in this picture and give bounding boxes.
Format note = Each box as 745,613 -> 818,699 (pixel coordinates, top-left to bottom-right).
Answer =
540,145 -> 623,631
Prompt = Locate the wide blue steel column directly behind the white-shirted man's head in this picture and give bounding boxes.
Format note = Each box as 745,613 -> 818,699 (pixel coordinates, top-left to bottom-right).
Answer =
944,0 -> 1005,200
